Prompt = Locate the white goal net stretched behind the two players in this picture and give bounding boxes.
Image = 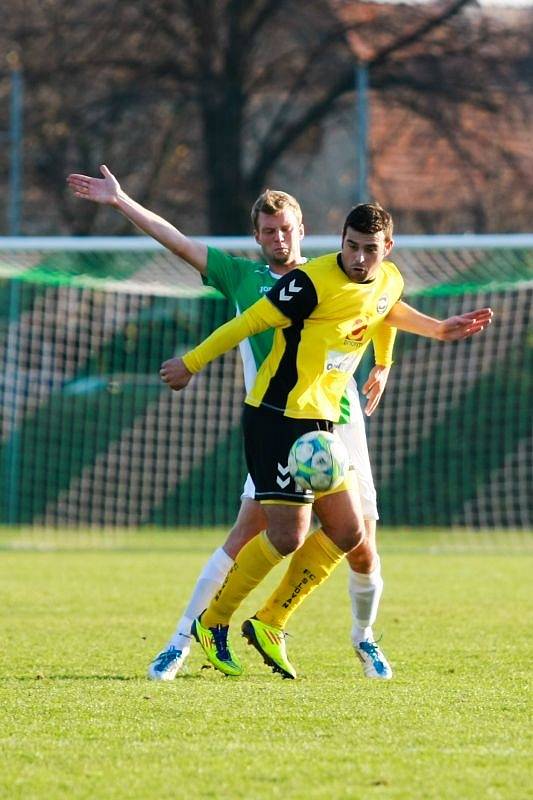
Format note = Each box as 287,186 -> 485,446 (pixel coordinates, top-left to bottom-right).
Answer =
0,236 -> 533,529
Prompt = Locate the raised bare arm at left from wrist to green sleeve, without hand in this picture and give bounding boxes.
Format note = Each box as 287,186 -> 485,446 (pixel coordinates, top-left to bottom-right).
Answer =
114,189 -> 207,272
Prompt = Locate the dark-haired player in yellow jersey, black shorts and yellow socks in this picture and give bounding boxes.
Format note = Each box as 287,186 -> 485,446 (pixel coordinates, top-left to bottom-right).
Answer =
161,204 -> 491,678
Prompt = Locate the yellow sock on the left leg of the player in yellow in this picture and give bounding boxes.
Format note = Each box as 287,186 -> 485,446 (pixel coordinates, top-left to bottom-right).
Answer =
202,531 -> 284,628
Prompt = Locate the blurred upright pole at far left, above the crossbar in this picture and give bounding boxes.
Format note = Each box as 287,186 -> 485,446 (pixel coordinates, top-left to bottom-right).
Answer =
7,53 -> 24,236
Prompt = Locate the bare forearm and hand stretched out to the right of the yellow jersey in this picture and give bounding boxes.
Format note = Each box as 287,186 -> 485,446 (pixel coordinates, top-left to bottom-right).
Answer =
386,301 -> 493,342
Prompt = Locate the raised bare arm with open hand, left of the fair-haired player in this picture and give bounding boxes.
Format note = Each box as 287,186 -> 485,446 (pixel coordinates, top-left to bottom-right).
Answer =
67,164 -> 207,275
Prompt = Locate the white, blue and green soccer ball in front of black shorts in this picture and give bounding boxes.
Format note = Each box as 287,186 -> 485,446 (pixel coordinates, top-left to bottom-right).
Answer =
289,431 -> 348,492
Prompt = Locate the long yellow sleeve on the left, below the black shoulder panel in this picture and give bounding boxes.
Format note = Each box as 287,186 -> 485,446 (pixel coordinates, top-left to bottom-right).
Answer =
183,297 -> 288,373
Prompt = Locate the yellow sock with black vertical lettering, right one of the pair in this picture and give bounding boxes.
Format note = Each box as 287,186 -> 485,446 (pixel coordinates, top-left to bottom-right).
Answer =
256,529 -> 345,628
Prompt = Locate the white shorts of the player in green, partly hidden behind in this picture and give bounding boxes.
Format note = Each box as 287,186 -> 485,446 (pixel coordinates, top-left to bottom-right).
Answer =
241,382 -> 379,520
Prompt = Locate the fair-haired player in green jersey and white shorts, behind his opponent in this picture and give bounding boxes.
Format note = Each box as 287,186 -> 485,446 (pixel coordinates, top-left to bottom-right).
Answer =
68,166 -> 394,680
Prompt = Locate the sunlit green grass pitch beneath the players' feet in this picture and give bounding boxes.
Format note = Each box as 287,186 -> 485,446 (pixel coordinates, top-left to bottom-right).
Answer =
0,531 -> 533,800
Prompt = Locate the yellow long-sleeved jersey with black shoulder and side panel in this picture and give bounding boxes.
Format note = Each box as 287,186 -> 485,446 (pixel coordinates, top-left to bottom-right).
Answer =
183,253 -> 403,422
